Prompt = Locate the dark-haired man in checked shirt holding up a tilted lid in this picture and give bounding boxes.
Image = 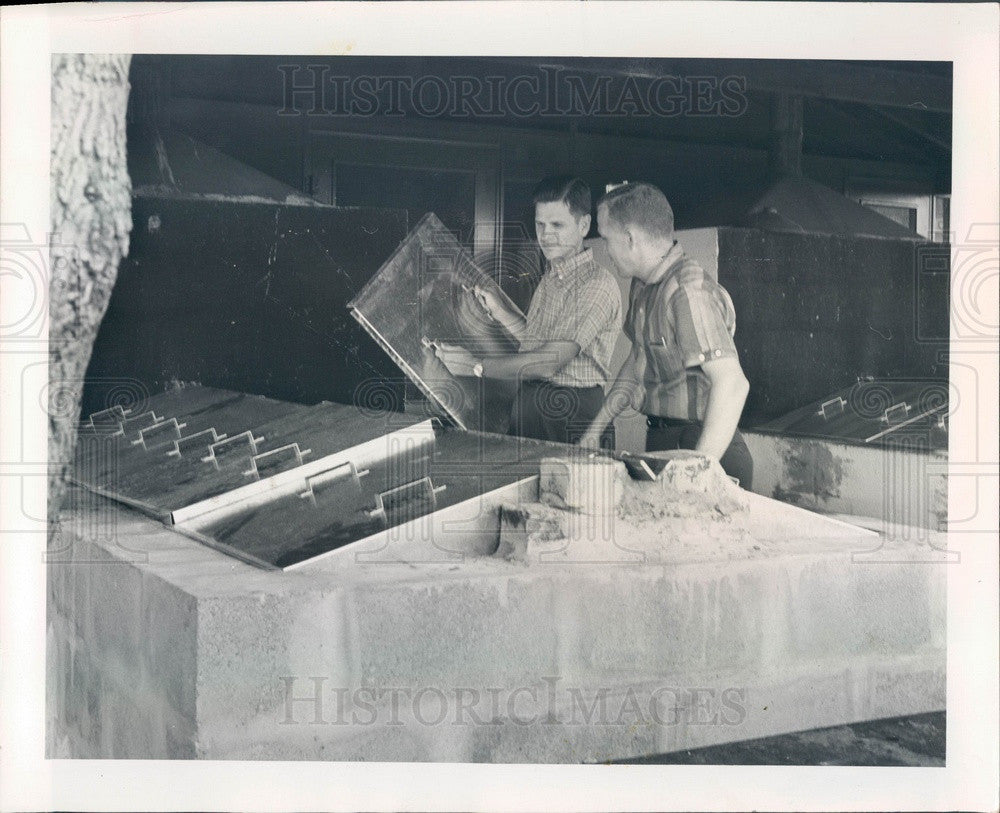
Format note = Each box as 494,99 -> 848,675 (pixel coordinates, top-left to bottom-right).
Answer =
437,176 -> 622,447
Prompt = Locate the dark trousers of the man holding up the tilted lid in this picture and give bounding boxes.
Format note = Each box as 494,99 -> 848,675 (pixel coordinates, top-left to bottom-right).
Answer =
507,381 -> 615,449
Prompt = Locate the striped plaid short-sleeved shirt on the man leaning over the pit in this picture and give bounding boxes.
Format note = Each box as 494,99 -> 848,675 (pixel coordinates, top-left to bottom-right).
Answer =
624,242 -> 739,420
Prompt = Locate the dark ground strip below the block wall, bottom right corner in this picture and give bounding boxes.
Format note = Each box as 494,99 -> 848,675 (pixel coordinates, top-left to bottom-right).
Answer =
615,711 -> 946,768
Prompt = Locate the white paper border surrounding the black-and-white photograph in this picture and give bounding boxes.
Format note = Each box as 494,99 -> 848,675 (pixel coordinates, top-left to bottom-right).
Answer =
0,0 -> 1000,811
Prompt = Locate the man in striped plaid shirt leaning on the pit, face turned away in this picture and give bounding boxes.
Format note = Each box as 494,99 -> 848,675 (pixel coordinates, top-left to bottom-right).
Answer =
582,183 -> 753,488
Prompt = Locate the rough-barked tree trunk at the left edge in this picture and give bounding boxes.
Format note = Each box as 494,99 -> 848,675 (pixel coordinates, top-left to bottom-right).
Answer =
49,54 -> 132,519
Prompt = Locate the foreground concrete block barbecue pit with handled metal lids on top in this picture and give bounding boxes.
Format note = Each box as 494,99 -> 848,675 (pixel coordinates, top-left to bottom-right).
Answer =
49,380 -> 945,762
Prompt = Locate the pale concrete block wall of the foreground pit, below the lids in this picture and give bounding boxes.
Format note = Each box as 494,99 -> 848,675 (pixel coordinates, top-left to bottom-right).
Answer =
48,464 -> 946,762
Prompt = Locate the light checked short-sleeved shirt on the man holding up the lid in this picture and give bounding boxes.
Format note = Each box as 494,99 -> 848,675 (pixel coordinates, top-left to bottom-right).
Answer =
521,248 -> 622,387
